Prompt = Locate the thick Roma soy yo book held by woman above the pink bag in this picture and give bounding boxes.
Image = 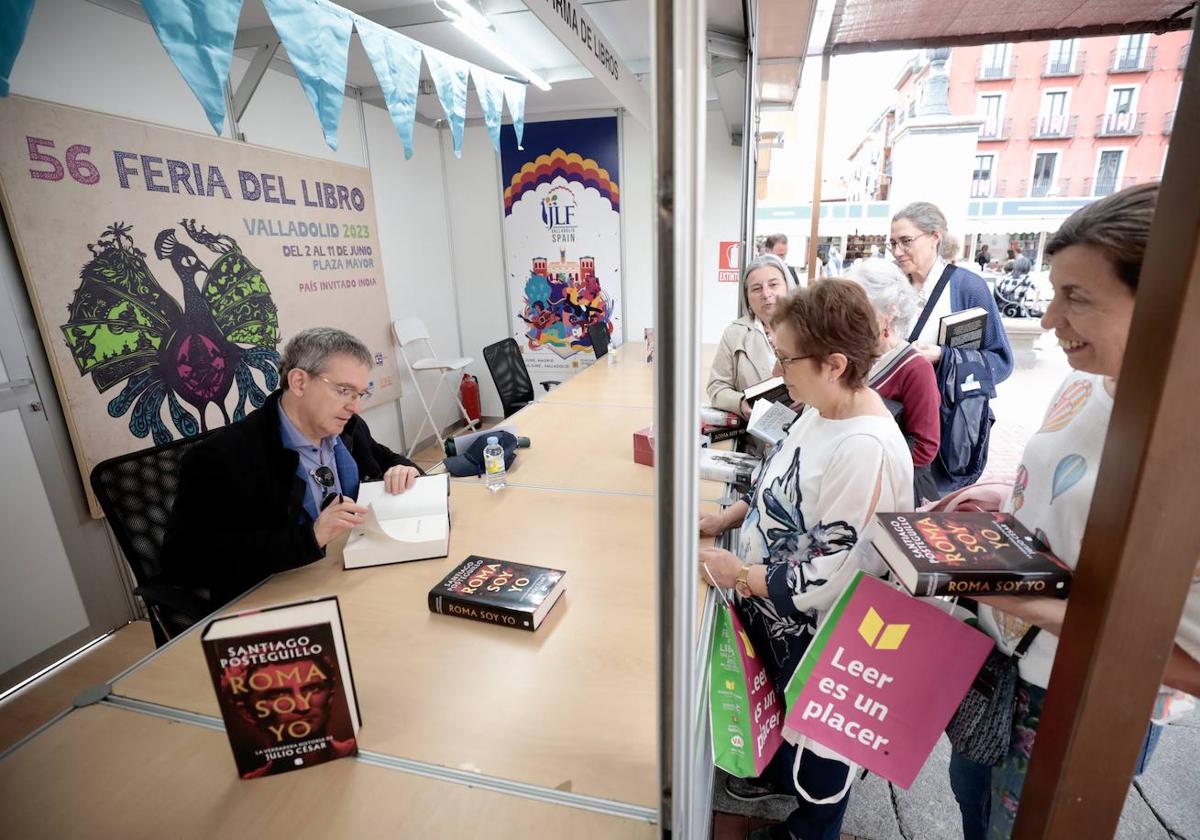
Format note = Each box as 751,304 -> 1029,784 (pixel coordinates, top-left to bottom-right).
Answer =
871,512 -> 1072,598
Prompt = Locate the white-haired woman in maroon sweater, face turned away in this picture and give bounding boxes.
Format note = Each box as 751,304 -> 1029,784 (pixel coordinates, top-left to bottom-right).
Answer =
847,257 -> 942,504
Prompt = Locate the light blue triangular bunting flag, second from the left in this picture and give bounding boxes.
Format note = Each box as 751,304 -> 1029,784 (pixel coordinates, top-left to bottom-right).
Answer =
142,0 -> 241,134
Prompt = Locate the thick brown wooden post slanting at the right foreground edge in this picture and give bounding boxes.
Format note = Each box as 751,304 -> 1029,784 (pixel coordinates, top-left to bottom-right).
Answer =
1013,16 -> 1200,840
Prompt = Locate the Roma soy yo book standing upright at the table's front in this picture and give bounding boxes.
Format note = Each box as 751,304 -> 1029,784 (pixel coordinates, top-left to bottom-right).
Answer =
202,596 -> 361,779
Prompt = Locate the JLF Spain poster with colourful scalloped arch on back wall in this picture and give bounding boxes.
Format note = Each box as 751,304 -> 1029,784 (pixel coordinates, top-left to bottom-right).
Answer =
500,116 -> 623,382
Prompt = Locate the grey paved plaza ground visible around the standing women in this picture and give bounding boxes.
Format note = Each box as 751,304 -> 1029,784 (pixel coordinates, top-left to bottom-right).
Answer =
713,334 -> 1200,840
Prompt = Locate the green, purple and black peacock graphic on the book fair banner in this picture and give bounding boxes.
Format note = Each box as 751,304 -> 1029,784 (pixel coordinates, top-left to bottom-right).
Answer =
62,218 -> 280,445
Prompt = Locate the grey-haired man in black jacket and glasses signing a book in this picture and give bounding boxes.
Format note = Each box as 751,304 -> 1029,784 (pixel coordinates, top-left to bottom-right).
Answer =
162,326 -> 420,607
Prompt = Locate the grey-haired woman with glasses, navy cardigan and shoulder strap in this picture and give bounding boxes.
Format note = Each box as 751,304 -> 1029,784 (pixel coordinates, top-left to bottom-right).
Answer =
888,202 -> 1013,493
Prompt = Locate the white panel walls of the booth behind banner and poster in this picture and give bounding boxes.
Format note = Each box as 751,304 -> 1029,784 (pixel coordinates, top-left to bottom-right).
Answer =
12,0 -> 740,448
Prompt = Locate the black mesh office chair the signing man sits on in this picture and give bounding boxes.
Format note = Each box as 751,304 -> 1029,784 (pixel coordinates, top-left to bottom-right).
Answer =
91,433 -> 212,647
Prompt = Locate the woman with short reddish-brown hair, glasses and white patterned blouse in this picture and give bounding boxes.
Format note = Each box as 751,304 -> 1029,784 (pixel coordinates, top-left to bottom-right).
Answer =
700,278 -> 913,840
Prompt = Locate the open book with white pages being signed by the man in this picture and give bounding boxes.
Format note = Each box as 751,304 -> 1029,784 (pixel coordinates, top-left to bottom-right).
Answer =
342,473 -> 450,569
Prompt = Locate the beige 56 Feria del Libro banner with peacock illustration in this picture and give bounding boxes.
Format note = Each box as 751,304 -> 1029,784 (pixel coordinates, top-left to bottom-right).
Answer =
0,97 -> 400,515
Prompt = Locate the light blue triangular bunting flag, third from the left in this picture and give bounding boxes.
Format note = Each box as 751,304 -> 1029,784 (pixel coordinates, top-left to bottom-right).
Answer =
263,0 -> 354,151
